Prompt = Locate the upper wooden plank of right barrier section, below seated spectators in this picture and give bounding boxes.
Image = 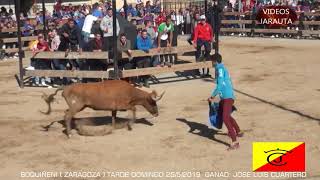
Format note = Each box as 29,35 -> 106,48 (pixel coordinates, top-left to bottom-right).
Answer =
122,46 -> 195,58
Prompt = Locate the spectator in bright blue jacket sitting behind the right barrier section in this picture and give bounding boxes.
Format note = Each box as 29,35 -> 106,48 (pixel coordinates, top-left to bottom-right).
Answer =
137,29 -> 152,87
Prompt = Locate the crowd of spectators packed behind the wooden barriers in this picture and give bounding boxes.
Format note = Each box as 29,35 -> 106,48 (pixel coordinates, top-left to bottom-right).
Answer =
0,0 -> 319,87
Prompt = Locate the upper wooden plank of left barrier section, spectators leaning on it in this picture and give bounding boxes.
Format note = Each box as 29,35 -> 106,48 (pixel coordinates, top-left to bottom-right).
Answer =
25,51 -> 109,59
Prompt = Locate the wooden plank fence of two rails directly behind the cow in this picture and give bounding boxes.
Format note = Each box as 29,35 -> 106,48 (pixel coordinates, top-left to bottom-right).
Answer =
23,46 -> 212,81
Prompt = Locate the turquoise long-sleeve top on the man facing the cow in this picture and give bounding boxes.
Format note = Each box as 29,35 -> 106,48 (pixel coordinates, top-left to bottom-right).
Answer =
211,63 -> 235,99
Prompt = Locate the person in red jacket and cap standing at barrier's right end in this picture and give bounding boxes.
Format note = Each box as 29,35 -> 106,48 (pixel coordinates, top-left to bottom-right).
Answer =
193,15 -> 213,61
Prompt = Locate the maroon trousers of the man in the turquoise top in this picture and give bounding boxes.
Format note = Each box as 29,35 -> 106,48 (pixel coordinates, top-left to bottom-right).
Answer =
219,99 -> 240,142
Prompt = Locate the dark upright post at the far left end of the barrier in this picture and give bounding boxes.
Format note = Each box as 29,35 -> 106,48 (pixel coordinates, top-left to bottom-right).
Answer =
14,0 -> 24,88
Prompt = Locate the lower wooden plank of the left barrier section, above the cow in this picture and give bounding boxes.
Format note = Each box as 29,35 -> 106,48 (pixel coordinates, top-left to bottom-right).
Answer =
25,70 -> 110,78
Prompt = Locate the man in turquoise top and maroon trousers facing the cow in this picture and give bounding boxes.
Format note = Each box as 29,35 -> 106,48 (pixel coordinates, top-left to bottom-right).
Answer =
208,54 -> 243,150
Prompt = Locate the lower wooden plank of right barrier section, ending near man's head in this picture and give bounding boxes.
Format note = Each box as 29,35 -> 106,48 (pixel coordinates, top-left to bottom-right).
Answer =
121,61 -> 212,78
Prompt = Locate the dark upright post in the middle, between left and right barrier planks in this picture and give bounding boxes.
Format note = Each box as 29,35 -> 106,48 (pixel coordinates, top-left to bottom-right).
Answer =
112,0 -> 119,79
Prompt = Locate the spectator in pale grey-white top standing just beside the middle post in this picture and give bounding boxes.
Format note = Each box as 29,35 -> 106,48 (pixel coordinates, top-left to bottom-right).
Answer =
100,8 -> 120,51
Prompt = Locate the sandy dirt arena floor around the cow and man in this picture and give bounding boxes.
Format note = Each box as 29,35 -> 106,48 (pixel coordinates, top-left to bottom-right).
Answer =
0,37 -> 320,180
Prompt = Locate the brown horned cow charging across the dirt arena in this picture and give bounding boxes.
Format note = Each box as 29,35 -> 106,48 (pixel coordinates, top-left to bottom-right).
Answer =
43,80 -> 164,137
